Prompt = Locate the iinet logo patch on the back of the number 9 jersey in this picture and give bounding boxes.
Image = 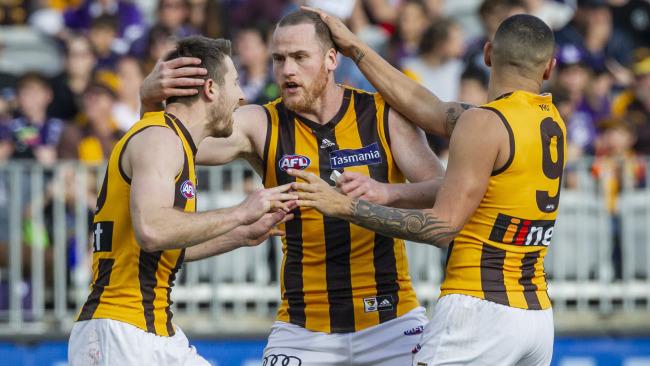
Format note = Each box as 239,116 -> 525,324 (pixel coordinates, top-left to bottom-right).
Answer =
490,214 -> 555,246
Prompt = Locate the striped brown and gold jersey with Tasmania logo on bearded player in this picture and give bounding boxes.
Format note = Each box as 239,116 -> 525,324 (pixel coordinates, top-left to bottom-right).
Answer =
264,88 -> 418,333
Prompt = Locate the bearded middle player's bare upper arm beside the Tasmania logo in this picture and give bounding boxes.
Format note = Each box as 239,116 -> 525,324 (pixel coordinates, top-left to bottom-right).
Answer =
388,109 -> 445,182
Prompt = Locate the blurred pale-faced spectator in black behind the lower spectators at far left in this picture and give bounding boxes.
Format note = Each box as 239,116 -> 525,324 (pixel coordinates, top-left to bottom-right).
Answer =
48,35 -> 97,121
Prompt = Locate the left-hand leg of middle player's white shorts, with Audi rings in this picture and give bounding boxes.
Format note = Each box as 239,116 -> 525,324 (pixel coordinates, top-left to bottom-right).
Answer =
262,322 -> 350,366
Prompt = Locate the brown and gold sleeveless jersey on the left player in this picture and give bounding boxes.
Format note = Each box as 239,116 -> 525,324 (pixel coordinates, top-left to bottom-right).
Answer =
78,112 -> 196,336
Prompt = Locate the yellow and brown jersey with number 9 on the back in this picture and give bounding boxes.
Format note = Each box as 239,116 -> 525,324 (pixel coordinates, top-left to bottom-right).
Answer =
441,91 -> 566,310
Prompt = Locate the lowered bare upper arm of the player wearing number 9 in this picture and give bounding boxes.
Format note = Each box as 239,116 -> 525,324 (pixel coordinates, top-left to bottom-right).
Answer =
433,111 -> 508,229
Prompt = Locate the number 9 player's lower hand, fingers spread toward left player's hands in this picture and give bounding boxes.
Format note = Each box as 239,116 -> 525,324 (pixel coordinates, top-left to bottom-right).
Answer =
287,169 -> 352,217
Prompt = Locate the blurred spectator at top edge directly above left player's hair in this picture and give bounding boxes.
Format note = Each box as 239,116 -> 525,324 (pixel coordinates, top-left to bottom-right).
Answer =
129,0 -> 198,58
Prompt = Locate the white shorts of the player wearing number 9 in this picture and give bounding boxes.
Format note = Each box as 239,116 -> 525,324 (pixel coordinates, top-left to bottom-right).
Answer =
412,294 -> 553,366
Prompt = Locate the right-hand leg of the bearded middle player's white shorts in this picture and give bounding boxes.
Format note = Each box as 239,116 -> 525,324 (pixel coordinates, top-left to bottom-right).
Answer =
350,307 -> 428,366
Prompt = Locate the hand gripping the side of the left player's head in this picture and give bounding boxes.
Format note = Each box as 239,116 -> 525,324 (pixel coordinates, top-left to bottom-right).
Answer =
140,57 -> 208,106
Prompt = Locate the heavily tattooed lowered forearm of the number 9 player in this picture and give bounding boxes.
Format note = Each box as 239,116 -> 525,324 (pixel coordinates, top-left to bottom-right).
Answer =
349,200 -> 458,247
